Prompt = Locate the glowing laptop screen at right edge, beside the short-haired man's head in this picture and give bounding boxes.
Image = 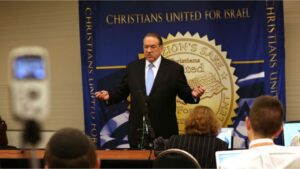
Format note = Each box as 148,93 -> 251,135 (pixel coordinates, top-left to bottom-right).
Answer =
283,121 -> 300,146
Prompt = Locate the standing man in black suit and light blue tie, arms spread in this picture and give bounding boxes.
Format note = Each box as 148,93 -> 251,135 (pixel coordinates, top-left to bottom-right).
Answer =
95,33 -> 204,148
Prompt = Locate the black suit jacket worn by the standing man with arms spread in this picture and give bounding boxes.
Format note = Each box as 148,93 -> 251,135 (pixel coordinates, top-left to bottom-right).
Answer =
109,57 -> 199,148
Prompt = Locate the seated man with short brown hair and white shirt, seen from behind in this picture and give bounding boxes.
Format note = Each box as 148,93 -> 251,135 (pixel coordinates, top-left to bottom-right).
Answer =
219,96 -> 300,169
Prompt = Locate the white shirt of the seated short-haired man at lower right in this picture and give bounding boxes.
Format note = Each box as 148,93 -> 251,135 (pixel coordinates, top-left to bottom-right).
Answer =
219,139 -> 300,169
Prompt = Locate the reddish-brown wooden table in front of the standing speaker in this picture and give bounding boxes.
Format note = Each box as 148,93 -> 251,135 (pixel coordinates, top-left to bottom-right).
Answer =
0,149 -> 155,168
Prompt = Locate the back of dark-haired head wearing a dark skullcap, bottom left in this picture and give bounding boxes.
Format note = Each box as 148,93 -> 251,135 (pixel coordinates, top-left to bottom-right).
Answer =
45,128 -> 99,168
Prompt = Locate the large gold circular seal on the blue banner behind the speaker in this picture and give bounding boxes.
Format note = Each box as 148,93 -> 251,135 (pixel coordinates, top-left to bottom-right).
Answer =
162,32 -> 238,134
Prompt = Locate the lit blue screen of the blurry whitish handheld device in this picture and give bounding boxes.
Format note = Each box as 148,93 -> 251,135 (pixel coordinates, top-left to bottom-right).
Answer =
14,55 -> 46,80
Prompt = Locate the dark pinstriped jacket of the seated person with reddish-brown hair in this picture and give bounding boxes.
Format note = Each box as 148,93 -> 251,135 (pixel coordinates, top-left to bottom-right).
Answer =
167,135 -> 228,168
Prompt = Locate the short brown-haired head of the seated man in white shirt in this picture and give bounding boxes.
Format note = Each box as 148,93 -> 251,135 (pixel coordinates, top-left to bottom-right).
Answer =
246,96 -> 283,141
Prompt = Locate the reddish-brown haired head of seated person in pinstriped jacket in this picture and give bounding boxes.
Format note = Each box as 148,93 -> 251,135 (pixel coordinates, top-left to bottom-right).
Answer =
185,106 -> 221,136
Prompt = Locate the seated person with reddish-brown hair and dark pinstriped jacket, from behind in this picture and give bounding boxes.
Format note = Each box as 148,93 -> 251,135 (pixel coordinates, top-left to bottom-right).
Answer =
167,106 -> 228,168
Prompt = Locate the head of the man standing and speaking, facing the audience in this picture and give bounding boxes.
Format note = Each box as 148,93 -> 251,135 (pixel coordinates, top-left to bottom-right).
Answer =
143,33 -> 163,63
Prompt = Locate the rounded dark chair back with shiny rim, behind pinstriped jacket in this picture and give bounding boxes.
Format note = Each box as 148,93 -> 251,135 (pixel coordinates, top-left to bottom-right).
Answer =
153,148 -> 201,168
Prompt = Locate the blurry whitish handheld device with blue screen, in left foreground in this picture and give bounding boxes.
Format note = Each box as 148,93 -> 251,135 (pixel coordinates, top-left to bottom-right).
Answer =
8,46 -> 50,121
